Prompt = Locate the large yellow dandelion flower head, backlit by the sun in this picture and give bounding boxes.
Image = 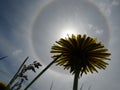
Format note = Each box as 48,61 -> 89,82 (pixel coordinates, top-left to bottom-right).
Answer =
51,34 -> 110,76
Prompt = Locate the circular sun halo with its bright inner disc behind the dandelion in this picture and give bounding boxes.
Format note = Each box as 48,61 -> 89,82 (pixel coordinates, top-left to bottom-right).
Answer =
31,0 -> 110,74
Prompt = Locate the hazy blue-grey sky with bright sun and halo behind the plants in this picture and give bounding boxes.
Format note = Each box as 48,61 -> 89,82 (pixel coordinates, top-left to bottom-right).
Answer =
0,0 -> 120,90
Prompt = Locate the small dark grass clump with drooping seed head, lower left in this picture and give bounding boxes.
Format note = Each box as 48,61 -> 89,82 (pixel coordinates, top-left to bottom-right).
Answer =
7,57 -> 42,90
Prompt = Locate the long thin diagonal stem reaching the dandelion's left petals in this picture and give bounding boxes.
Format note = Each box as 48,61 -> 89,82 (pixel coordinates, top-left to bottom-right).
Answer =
24,54 -> 62,90
